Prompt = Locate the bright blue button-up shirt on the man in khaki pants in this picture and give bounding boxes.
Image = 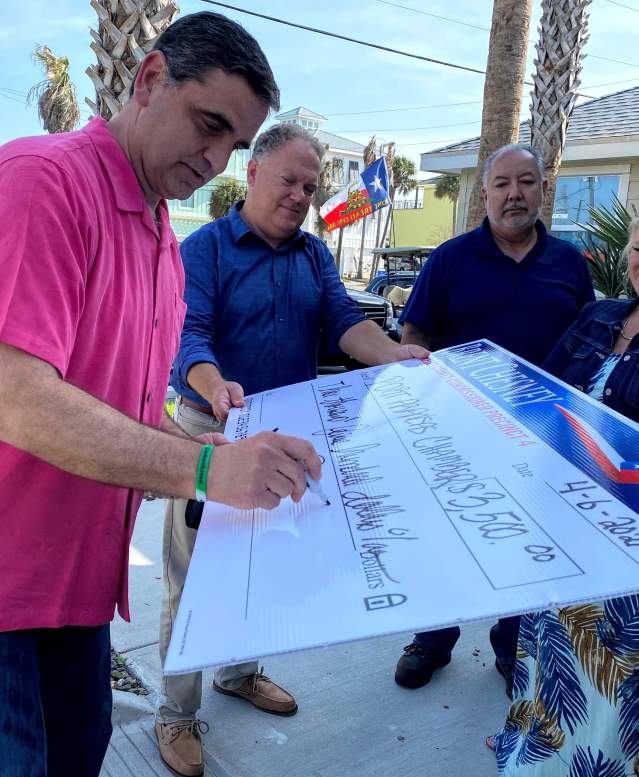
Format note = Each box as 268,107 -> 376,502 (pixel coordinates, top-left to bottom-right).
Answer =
171,203 -> 365,404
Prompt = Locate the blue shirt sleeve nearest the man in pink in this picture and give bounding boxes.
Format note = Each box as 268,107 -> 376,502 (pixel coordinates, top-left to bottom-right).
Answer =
171,223 -> 219,400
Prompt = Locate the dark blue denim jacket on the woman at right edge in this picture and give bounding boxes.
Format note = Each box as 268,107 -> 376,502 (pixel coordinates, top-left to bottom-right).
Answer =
542,299 -> 639,421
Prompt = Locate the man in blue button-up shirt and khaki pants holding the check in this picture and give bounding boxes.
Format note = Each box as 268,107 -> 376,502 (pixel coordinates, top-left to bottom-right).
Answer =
158,125 -> 428,764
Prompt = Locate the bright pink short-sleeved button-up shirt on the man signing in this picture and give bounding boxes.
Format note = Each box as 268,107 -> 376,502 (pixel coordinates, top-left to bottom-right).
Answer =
0,119 -> 184,631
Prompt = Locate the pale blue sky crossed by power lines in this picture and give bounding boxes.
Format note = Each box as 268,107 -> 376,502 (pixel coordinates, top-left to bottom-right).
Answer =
0,0 -> 639,170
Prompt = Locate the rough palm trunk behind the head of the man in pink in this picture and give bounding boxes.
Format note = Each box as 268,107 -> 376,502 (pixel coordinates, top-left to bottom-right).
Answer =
86,0 -> 179,119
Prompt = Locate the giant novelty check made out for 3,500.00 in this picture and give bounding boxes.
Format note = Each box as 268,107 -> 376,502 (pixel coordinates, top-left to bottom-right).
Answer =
165,341 -> 639,673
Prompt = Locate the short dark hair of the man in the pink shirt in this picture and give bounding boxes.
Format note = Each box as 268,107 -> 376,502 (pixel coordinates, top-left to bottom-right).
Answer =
142,11 -> 280,111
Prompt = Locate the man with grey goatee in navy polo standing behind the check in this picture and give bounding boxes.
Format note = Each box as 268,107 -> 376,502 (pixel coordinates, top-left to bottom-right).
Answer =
395,144 -> 594,695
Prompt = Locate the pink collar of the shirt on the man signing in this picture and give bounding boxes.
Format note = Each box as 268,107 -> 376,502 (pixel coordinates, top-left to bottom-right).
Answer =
82,118 -> 148,213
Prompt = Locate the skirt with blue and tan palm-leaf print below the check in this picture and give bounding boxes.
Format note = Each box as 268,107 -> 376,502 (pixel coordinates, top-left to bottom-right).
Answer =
495,596 -> 639,777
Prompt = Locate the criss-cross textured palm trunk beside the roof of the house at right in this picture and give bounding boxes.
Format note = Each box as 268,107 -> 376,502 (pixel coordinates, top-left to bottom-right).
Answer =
530,0 -> 591,229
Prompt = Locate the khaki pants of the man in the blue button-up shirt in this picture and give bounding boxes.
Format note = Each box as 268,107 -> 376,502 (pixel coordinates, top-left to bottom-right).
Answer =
156,398 -> 257,723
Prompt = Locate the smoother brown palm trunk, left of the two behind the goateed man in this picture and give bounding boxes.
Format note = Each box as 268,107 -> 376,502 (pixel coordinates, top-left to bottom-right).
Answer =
466,0 -> 532,230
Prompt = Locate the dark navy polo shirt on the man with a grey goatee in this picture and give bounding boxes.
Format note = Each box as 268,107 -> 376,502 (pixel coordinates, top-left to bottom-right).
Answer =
400,218 -> 594,365
